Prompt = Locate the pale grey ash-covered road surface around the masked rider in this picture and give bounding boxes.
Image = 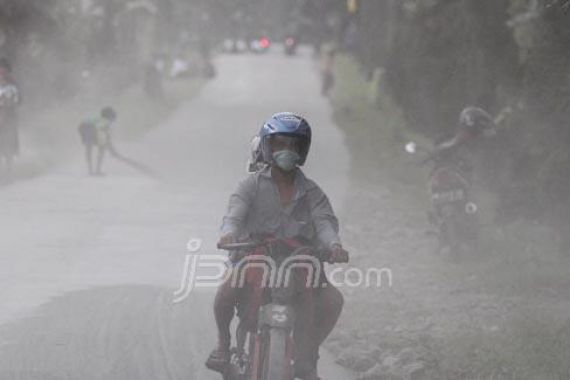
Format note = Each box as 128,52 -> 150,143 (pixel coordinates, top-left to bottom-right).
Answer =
0,52 -> 351,380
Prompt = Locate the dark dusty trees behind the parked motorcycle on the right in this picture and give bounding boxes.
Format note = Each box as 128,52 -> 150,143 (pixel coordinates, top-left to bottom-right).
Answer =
348,0 -> 570,235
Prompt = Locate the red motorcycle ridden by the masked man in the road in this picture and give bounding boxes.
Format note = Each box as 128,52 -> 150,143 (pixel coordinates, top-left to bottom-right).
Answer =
218,239 -> 330,380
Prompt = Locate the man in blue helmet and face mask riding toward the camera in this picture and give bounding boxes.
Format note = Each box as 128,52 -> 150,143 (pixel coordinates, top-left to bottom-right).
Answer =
206,112 -> 348,380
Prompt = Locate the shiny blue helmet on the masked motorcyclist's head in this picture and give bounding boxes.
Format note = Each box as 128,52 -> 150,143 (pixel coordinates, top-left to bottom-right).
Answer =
259,112 -> 312,165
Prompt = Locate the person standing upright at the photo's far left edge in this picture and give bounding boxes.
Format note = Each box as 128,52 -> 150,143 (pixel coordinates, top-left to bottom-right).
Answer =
0,58 -> 20,182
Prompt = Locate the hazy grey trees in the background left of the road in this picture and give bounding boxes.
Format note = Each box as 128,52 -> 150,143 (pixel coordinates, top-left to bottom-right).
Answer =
0,0 -> 222,104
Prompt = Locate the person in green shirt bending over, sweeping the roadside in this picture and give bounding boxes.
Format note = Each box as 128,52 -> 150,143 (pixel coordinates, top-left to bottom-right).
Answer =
79,107 -> 117,176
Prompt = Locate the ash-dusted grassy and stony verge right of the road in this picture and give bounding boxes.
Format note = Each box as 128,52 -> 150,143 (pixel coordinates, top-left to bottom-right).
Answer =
328,56 -> 570,380
